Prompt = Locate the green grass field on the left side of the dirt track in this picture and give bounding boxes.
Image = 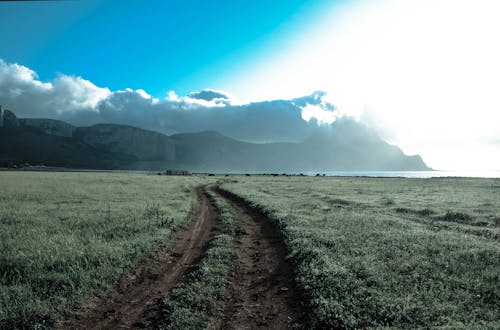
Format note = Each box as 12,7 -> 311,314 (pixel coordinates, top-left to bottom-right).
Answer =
0,172 -> 202,328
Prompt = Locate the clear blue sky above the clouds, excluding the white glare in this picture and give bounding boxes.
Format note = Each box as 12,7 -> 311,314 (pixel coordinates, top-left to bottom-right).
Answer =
0,0 -> 332,96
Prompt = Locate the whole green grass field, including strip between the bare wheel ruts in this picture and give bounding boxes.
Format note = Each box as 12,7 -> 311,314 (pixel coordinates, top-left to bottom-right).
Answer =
0,172 -> 500,329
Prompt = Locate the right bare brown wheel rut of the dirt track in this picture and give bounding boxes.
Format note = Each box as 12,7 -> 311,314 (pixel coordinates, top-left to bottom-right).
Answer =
208,189 -> 301,329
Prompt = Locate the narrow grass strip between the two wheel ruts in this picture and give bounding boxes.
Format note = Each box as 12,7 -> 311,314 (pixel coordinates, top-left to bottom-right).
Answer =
153,187 -> 242,329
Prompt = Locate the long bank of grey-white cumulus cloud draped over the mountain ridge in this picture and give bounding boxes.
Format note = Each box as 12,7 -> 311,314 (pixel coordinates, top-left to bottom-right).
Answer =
0,60 -> 346,142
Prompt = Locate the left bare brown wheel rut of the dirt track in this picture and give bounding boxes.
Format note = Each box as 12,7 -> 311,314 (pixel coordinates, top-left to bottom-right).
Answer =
56,187 -> 217,329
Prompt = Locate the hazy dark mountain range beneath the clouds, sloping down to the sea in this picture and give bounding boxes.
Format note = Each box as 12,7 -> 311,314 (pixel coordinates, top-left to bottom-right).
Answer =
0,107 -> 429,172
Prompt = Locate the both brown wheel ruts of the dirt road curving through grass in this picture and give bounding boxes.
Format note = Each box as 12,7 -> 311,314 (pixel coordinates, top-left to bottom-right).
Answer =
56,187 -> 301,329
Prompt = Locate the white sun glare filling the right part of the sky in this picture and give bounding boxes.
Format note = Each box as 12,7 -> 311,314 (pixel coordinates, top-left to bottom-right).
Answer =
222,0 -> 500,170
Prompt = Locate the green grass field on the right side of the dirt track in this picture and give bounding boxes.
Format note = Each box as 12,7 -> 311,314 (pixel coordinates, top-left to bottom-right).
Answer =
223,176 -> 500,329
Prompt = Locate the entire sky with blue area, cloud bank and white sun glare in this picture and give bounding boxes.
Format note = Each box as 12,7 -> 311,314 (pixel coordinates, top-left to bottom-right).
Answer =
0,0 -> 500,170
